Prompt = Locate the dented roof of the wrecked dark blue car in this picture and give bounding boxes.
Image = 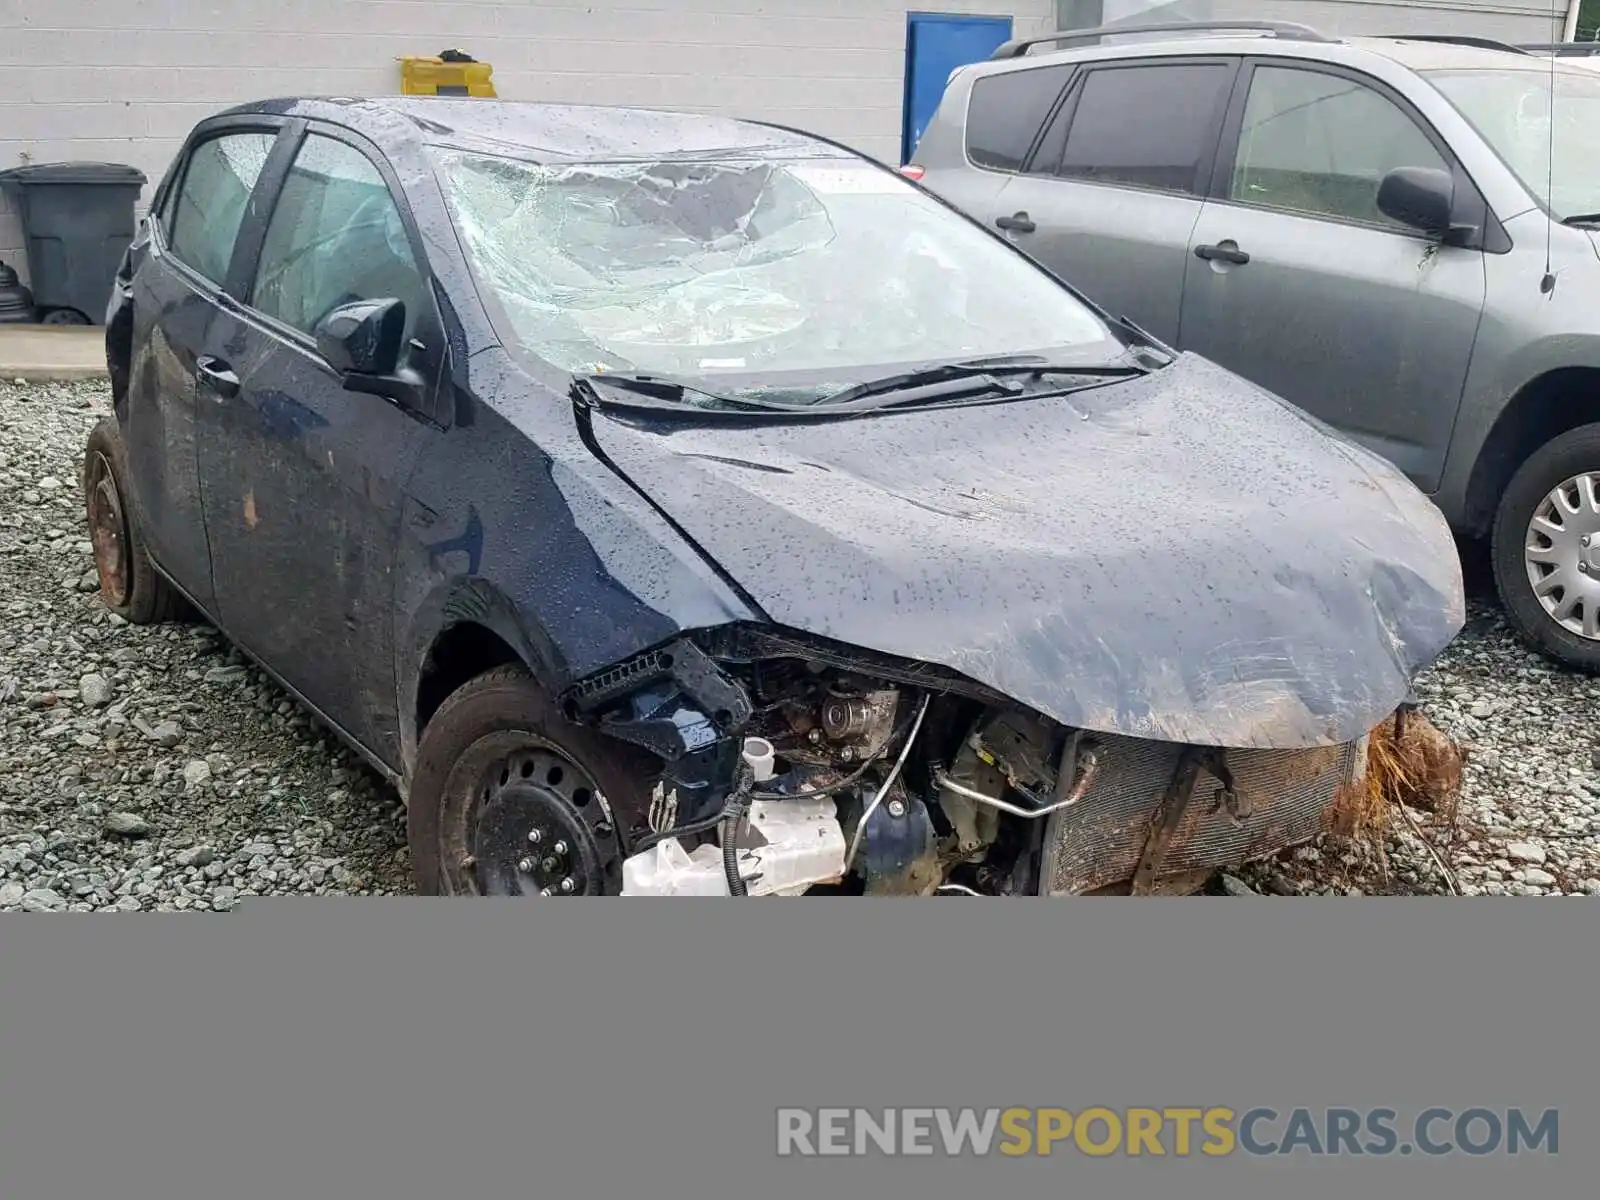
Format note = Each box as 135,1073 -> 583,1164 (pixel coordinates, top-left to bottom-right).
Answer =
208,96 -> 858,162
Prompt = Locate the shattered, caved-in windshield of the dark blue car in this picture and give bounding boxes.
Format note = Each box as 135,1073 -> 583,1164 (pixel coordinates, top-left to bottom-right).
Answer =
437,150 -> 1123,402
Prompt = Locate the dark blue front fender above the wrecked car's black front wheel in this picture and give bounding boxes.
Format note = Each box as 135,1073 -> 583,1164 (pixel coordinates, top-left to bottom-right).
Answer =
395,352 -> 760,774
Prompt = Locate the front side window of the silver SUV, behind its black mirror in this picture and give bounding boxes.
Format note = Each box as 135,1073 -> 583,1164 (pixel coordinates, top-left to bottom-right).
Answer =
1229,67 -> 1450,234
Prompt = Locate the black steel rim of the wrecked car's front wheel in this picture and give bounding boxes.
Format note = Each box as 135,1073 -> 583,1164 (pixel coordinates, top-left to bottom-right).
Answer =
440,731 -> 622,898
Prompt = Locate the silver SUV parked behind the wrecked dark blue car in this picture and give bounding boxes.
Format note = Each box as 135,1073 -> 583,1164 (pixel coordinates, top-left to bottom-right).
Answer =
902,22 -> 1600,672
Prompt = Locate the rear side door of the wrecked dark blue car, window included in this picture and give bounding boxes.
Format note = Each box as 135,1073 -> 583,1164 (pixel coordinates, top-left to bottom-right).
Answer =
123,125 -> 278,608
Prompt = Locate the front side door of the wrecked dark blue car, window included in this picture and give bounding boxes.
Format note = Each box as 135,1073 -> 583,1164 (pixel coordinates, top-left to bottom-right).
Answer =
200,125 -> 445,765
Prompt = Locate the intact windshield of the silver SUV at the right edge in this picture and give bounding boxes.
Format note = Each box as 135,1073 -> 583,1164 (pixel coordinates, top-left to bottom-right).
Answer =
1424,66 -> 1600,221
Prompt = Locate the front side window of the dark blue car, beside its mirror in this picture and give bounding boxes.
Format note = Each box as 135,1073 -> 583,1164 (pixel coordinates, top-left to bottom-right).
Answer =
250,134 -> 426,356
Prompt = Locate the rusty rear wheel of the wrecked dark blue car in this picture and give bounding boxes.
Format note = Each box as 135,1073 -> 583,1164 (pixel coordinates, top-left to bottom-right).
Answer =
82,418 -> 187,626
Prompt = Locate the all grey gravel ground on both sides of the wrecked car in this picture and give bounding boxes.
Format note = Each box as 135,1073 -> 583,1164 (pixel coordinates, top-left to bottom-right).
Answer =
0,382 -> 1600,910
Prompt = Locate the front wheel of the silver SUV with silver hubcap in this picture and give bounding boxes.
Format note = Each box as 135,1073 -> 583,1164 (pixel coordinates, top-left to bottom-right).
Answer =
1493,424 -> 1600,674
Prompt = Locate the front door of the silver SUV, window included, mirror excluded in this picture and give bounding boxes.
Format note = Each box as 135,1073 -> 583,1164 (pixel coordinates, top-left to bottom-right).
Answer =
1178,59 -> 1486,491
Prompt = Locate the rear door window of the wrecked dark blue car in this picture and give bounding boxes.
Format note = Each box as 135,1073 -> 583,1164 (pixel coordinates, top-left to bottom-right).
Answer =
170,133 -> 277,283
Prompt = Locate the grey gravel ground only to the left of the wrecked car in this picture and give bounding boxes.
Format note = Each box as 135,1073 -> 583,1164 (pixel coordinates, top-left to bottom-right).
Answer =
0,382 -> 410,910
